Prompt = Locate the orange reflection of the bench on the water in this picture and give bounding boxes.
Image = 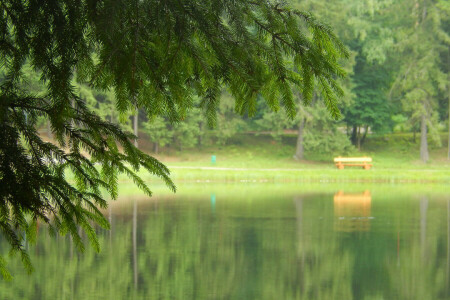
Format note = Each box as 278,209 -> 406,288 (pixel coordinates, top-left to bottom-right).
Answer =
333,191 -> 372,232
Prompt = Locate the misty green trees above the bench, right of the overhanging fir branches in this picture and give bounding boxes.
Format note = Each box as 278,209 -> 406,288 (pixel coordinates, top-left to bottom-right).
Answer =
294,0 -> 450,157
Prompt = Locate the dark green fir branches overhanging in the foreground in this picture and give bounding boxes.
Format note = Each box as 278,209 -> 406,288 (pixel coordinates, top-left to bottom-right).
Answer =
0,0 -> 347,276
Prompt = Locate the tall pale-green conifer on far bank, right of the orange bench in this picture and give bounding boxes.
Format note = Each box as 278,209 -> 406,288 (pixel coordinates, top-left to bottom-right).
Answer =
392,0 -> 446,162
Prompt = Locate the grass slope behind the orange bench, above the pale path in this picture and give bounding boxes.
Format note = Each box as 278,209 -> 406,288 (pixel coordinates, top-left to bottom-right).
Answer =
154,134 -> 450,170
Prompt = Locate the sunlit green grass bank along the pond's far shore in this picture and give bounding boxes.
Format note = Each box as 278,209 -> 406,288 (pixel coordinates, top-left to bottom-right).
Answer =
125,134 -> 450,183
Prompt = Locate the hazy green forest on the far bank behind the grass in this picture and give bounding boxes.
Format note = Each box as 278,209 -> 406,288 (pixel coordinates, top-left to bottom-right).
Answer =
6,0 -> 450,163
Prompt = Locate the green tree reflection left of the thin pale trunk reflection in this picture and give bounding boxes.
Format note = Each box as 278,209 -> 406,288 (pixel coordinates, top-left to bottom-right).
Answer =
0,219 -> 132,299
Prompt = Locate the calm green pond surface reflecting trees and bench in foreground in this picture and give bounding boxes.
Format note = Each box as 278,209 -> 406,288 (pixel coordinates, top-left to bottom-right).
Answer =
0,184 -> 450,300
